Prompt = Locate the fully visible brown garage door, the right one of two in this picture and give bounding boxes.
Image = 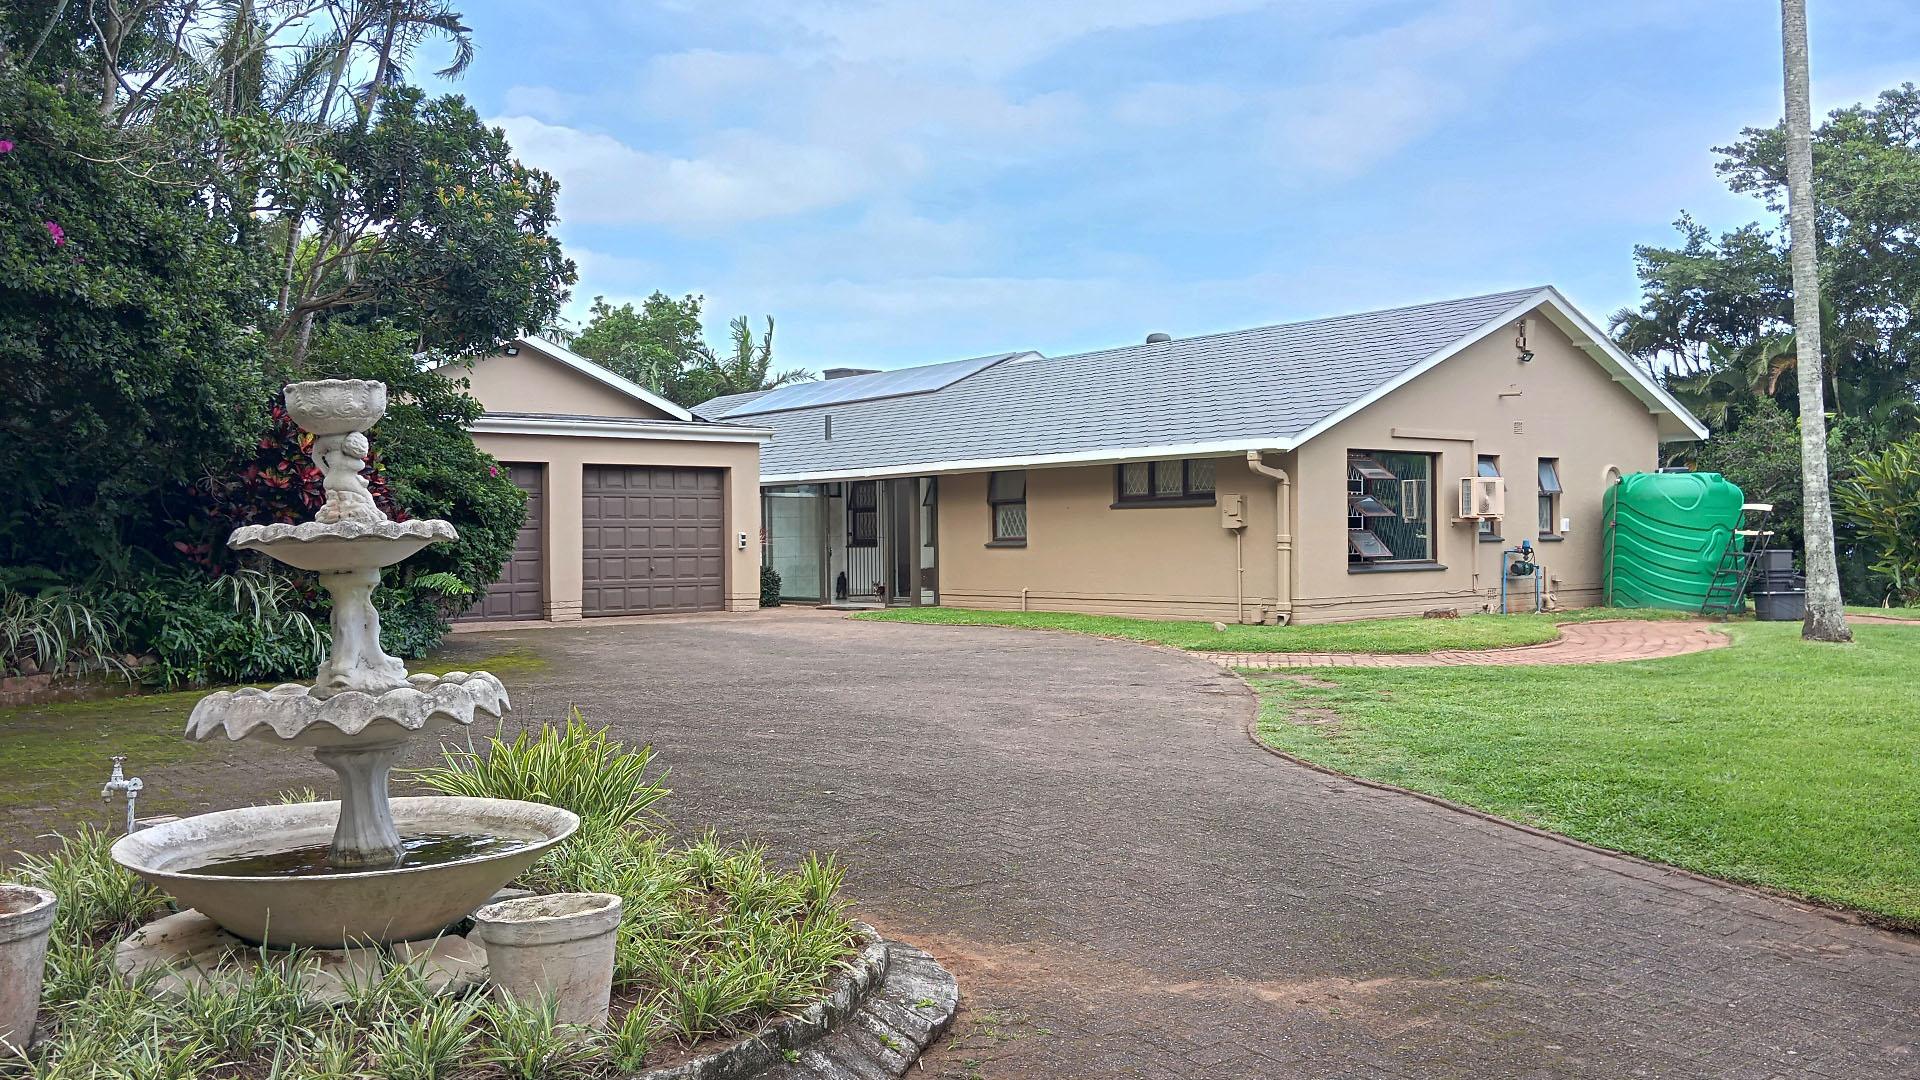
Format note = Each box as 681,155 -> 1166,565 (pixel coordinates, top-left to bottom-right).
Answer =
580,465 -> 726,615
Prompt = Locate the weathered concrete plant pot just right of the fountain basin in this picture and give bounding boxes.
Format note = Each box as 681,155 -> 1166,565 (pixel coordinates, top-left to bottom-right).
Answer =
474,892 -> 620,1028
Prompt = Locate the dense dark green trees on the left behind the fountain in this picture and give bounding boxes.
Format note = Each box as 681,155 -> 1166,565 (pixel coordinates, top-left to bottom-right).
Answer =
0,0 -> 574,675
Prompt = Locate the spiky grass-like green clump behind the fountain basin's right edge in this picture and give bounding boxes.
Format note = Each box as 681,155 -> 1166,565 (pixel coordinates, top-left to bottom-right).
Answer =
413,709 -> 668,832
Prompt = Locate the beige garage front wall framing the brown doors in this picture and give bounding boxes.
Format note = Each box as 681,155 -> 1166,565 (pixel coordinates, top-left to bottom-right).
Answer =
474,428 -> 760,621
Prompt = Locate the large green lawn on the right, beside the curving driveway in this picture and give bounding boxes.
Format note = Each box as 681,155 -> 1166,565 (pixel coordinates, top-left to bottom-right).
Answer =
1248,623 -> 1920,928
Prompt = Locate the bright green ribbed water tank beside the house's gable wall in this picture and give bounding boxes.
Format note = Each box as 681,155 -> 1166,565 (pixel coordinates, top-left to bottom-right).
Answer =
1605,473 -> 1745,611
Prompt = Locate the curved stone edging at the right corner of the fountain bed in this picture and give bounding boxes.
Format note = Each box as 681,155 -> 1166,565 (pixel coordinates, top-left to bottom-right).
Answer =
630,922 -> 960,1080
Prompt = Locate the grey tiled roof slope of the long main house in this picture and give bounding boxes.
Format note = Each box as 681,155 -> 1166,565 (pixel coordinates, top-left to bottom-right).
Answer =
733,288 -> 1540,477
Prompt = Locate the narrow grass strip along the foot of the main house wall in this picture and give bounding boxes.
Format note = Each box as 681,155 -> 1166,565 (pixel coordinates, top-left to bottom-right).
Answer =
854,607 -> 1684,653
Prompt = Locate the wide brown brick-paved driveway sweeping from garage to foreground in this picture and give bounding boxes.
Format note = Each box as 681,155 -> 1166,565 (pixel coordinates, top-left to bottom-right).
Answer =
428,613 -> 1920,1078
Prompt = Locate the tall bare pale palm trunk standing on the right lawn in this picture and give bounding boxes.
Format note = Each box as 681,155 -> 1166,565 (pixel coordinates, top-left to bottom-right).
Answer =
1780,0 -> 1853,642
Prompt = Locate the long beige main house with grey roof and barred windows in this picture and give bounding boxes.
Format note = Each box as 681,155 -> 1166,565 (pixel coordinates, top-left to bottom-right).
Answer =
695,288 -> 1707,623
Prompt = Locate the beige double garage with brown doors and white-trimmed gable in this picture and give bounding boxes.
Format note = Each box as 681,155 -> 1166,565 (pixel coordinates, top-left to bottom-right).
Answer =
442,338 -> 772,623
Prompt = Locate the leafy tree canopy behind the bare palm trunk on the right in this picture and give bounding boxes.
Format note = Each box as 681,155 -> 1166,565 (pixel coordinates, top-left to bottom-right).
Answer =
1613,83 -> 1920,434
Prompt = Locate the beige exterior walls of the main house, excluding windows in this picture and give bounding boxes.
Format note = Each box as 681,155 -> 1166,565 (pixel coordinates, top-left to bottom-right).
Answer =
921,307 -> 1659,623
